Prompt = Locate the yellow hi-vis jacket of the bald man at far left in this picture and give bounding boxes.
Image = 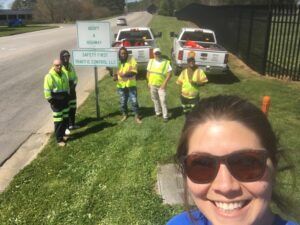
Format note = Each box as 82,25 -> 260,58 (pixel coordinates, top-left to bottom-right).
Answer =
44,68 -> 70,100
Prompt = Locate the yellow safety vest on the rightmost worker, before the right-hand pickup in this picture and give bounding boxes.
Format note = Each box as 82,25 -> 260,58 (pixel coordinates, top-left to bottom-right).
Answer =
176,68 -> 208,99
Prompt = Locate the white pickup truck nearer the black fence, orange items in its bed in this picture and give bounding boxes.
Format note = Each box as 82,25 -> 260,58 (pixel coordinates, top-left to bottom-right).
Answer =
170,28 -> 228,73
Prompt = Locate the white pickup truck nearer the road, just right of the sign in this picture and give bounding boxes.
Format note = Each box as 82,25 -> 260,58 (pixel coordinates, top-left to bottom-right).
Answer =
112,27 -> 161,66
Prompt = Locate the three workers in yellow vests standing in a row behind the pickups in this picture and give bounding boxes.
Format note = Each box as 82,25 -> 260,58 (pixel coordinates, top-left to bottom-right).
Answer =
113,47 -> 208,123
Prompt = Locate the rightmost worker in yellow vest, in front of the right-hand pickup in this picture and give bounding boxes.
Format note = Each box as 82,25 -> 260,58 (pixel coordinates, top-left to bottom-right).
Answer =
176,51 -> 208,115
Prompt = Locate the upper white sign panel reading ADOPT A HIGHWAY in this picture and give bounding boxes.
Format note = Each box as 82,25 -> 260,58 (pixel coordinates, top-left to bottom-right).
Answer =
76,21 -> 111,49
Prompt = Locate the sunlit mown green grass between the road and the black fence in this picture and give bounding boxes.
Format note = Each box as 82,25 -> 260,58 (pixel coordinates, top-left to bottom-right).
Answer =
0,16 -> 300,225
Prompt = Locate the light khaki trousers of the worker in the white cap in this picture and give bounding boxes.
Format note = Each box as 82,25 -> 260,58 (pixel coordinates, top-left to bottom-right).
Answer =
150,85 -> 168,119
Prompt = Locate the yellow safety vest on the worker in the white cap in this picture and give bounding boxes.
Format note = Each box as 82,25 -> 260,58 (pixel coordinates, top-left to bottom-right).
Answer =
148,59 -> 170,86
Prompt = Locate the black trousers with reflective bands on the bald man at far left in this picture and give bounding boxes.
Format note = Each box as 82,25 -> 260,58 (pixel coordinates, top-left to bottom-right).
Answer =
51,98 -> 69,142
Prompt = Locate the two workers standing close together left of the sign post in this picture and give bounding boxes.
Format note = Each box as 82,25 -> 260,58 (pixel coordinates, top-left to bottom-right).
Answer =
44,50 -> 79,146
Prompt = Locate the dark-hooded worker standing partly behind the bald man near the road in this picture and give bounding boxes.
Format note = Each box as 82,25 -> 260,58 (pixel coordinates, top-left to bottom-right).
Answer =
60,50 -> 79,131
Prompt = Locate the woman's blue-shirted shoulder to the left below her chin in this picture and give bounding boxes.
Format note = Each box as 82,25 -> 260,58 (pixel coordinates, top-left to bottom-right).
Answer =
167,210 -> 210,225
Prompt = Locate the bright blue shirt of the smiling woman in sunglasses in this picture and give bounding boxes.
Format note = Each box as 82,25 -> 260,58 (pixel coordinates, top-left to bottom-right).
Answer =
167,210 -> 298,225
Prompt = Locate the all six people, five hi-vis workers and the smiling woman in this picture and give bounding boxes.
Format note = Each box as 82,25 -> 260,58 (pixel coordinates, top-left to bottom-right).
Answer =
44,47 -> 297,225
